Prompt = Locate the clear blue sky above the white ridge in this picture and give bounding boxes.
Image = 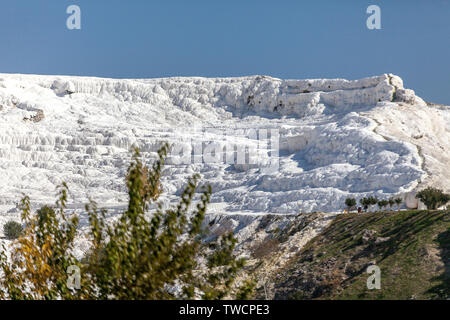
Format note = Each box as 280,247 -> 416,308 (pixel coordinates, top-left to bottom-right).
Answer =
0,0 -> 450,104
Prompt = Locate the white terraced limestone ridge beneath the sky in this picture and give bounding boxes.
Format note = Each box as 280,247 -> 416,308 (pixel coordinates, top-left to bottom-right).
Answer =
0,74 -> 450,214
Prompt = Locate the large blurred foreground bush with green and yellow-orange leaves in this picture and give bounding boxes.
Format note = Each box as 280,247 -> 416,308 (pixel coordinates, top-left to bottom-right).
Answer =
0,144 -> 252,300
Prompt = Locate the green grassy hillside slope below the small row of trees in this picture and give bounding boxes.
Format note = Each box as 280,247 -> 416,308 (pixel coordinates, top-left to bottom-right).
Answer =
273,210 -> 450,299
